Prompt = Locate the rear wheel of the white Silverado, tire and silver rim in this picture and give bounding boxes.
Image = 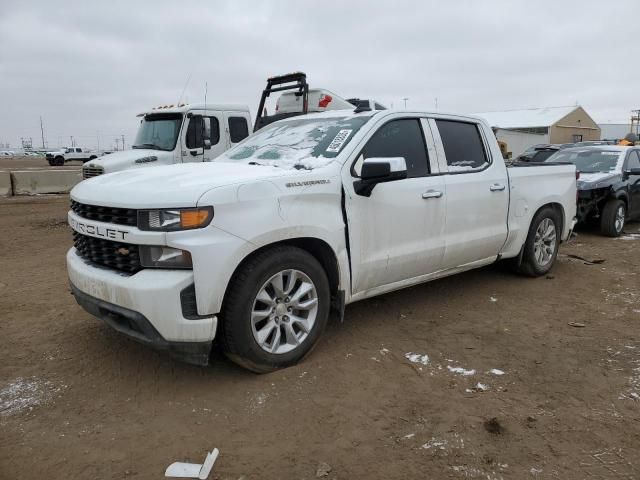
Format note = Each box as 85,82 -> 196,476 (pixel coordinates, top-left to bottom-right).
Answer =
518,207 -> 560,277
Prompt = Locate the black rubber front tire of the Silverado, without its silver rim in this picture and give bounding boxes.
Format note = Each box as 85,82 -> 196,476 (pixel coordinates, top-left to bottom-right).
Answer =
220,245 -> 330,373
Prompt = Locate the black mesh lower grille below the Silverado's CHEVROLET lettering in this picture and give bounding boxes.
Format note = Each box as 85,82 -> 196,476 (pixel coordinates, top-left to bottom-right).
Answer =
73,232 -> 142,274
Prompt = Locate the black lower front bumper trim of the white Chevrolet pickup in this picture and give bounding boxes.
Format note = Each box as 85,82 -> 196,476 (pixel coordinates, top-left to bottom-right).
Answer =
71,283 -> 211,365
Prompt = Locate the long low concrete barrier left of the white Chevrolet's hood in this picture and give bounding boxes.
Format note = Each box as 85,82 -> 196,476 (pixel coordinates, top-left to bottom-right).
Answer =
11,169 -> 82,195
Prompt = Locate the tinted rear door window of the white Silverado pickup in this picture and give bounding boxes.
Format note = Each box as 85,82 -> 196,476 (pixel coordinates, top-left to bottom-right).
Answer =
436,120 -> 489,172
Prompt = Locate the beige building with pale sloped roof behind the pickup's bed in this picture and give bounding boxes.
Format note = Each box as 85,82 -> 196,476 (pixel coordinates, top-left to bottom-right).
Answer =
475,105 -> 600,156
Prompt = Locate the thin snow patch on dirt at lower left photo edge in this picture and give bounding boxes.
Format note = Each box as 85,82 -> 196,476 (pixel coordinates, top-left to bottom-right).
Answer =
0,377 -> 61,416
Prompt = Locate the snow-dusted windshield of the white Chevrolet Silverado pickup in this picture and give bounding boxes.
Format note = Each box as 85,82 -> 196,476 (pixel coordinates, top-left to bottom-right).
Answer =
226,115 -> 371,170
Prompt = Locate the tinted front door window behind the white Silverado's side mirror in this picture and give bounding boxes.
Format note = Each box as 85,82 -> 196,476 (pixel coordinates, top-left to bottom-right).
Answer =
353,118 -> 429,178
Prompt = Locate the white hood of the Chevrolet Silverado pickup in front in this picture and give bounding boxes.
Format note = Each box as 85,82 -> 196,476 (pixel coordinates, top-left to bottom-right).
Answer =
71,161 -> 295,208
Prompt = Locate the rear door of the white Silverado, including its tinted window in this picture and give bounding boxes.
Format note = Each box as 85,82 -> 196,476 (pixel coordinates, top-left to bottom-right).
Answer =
430,119 -> 509,269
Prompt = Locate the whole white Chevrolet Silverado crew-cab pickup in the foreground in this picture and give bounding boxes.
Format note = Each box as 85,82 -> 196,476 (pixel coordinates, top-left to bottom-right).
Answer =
67,106 -> 576,372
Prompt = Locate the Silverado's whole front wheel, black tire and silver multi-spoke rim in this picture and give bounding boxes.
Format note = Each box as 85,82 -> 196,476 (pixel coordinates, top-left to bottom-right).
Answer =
221,246 -> 330,373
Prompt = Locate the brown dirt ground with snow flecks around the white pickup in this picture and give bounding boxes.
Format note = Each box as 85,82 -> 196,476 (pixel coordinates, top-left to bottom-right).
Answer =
0,196 -> 640,480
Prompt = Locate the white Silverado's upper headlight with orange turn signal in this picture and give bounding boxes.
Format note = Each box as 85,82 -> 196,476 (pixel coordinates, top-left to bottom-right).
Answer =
138,207 -> 213,232
